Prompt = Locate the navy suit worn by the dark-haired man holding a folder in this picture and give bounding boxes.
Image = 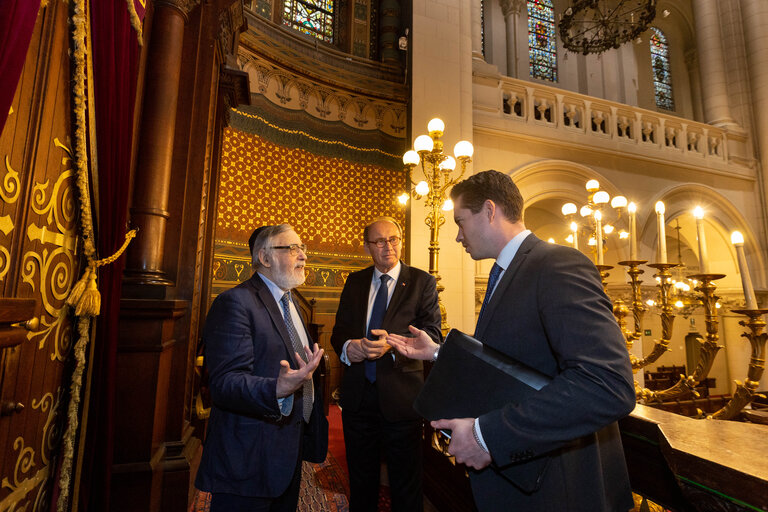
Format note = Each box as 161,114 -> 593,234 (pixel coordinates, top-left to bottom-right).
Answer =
471,234 -> 635,512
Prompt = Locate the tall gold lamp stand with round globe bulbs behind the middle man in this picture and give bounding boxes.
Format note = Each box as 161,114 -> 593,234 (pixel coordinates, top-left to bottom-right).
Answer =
398,118 -> 474,335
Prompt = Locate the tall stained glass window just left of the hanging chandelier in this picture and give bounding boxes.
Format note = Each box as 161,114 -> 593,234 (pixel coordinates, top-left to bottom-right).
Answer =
527,0 -> 557,82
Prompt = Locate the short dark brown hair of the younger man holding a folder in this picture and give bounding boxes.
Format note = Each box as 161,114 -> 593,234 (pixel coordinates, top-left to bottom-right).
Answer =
451,169 -> 524,222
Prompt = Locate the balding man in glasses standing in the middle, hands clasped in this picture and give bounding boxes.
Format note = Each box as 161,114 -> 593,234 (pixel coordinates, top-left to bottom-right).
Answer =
331,217 -> 440,512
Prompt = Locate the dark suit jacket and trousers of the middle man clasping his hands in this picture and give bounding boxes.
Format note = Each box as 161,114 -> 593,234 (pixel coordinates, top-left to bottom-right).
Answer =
331,263 -> 441,512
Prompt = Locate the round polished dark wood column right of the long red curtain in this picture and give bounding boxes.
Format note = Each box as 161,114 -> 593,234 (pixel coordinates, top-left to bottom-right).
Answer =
125,0 -> 200,285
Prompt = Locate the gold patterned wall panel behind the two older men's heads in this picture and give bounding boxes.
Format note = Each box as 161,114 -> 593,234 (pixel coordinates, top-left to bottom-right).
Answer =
216,128 -> 405,256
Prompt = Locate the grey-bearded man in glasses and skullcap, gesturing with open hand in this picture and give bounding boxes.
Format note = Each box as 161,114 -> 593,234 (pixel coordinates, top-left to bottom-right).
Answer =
195,224 -> 328,512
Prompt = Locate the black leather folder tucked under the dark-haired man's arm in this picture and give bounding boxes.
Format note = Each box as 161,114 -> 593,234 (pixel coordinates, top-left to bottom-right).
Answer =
413,329 -> 551,493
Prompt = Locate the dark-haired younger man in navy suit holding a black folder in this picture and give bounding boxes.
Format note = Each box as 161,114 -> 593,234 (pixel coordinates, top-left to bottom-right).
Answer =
387,171 -> 635,512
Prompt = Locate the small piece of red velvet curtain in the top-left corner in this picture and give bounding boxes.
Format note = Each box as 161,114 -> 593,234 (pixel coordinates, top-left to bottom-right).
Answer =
0,0 -> 40,132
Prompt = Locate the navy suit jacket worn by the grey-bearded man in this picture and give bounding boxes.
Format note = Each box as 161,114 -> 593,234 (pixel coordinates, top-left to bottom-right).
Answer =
195,273 -> 328,498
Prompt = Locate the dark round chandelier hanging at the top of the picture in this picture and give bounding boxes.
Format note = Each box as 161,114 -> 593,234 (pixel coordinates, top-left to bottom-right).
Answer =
558,0 -> 656,55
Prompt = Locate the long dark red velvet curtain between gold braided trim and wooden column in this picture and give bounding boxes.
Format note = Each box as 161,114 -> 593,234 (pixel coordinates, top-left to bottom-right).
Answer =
79,0 -> 143,511
